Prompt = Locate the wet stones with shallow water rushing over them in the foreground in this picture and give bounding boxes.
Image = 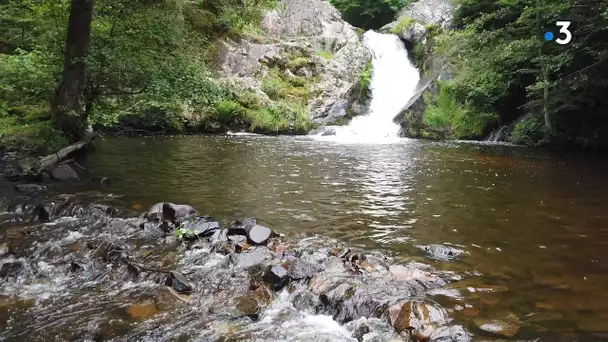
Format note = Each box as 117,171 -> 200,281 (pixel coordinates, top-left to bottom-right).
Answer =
0,186 -> 476,341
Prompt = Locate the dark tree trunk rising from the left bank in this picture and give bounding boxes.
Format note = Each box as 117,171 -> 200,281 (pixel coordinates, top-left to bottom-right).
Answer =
53,0 -> 94,140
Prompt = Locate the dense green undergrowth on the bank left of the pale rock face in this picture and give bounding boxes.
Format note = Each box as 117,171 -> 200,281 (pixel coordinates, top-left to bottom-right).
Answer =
0,0 -> 312,149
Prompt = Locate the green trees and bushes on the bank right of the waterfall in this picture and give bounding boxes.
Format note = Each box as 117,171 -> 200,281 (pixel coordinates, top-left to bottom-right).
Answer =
433,0 -> 608,148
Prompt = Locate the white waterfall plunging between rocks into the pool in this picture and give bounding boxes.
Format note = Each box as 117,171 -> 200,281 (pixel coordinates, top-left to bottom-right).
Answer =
314,31 -> 420,143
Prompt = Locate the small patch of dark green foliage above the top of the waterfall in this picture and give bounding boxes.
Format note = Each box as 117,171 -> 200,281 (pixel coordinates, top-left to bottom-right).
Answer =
329,0 -> 414,30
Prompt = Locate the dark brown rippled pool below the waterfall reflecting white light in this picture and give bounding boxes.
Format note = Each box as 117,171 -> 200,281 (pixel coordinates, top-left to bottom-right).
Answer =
75,136 -> 608,341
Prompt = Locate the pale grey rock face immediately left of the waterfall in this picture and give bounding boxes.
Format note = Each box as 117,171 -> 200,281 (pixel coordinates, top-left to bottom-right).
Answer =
219,0 -> 371,123
